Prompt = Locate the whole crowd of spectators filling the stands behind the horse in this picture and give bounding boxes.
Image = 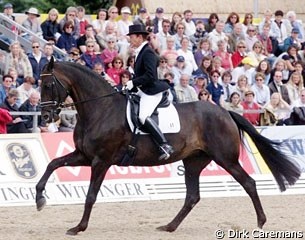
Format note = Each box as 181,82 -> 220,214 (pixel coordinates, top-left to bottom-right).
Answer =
0,3 -> 305,132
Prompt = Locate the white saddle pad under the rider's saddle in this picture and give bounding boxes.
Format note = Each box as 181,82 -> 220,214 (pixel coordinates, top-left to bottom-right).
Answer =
126,101 -> 180,134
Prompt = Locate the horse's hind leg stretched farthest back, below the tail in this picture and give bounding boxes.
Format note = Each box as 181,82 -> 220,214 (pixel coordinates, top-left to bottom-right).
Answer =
215,159 -> 267,228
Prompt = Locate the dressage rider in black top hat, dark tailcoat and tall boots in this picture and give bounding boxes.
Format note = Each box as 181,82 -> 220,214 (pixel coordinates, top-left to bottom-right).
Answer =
126,25 -> 174,160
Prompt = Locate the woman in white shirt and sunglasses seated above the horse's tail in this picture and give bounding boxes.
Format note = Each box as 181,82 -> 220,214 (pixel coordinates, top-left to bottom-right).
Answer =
251,72 -> 270,106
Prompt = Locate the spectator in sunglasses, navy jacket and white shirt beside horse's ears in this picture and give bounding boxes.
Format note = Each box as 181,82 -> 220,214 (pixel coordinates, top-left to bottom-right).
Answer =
28,41 -> 49,86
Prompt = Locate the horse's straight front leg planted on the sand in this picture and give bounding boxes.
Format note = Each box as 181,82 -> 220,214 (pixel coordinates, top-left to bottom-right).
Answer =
67,157 -> 110,235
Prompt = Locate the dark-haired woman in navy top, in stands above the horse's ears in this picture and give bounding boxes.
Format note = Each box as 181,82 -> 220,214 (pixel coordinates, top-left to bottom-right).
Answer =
56,21 -> 77,53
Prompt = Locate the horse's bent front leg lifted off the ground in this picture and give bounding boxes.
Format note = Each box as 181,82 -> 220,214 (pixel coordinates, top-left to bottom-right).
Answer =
36,151 -> 91,211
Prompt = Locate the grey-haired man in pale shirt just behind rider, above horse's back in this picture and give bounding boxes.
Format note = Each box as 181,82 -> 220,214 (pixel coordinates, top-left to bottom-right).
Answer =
175,74 -> 198,103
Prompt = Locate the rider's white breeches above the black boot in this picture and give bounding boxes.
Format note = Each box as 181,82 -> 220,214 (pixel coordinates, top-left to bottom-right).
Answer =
137,89 -> 163,124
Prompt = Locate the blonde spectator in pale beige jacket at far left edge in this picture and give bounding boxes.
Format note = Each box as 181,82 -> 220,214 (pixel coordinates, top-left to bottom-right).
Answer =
4,42 -> 33,84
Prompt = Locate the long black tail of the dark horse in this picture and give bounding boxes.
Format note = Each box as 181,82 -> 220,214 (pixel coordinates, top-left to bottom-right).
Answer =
229,111 -> 301,191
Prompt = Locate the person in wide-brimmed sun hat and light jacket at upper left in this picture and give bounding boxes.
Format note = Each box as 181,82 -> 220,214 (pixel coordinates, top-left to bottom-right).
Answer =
22,7 -> 42,39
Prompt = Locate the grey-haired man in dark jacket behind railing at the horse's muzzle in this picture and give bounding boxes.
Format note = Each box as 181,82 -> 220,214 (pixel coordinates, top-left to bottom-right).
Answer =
19,91 -> 48,132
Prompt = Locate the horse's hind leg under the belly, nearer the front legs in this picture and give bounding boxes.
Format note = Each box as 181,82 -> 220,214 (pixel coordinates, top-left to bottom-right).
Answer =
157,157 -> 211,232
